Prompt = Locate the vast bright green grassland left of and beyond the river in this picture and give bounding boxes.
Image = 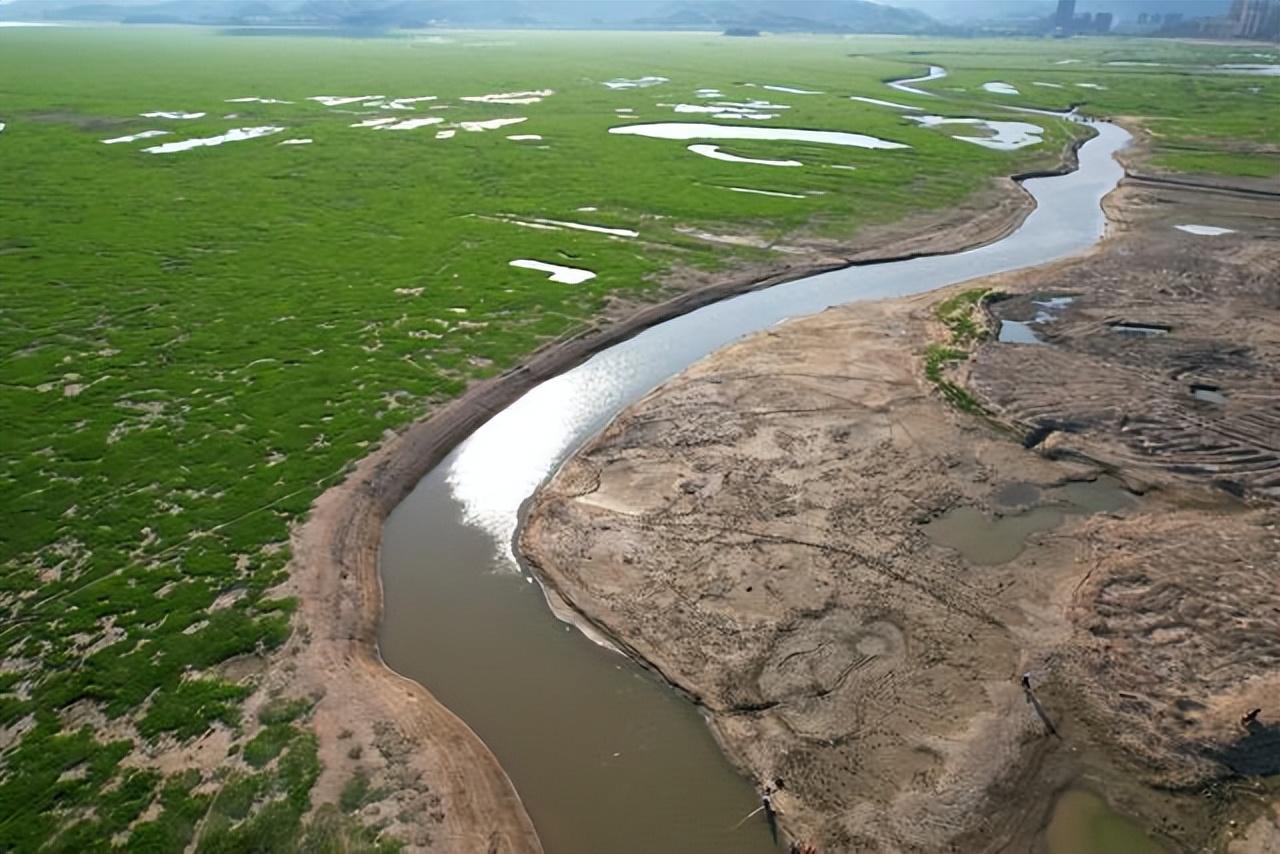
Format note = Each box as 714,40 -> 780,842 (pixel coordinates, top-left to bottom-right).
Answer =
0,28 -> 1280,851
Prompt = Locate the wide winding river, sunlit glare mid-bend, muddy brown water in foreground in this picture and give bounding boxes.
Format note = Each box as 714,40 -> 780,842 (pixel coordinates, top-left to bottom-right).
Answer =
380,123 -> 1129,854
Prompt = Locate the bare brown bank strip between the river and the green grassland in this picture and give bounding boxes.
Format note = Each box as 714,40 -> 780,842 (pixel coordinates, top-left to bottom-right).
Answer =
277,133 -> 1083,854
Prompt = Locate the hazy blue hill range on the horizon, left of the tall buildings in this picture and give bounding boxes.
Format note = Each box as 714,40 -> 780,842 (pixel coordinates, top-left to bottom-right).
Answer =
0,0 -> 941,33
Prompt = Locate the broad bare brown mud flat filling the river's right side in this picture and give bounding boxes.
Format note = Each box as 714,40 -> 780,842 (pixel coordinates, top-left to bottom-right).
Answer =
521,181 -> 1280,853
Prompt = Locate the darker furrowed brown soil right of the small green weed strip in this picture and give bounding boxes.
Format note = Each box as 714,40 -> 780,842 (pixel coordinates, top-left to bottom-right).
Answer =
969,182 -> 1280,498
